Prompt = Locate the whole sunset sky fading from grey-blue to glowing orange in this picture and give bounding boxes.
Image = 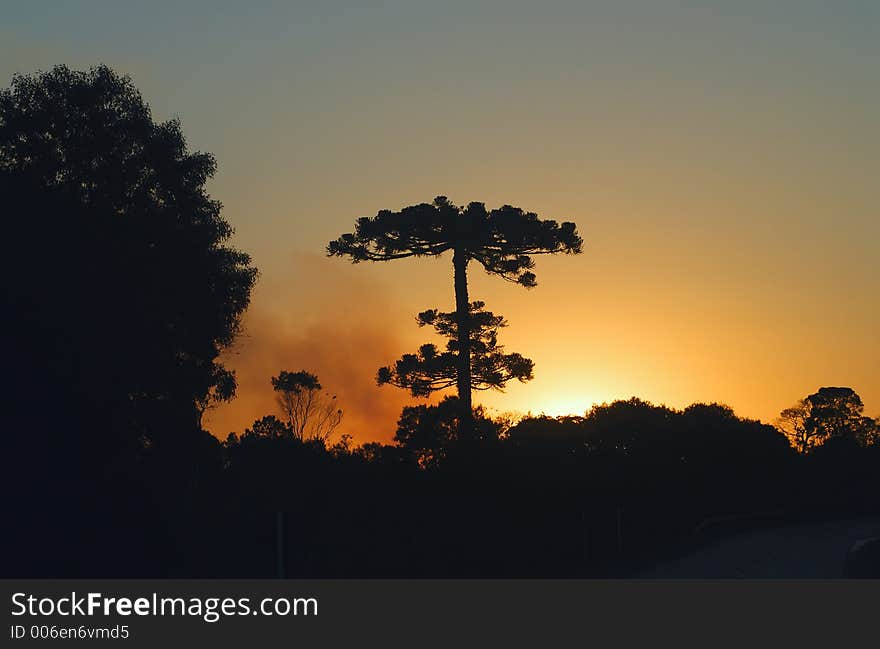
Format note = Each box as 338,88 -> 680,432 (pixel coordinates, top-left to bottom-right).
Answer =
0,0 -> 880,441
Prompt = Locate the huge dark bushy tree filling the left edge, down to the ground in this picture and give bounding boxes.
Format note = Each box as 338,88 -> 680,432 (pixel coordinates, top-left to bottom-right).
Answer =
0,66 -> 256,576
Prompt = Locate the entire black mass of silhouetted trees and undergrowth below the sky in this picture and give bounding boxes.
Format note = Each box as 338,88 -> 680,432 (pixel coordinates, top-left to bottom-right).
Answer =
0,66 -> 880,577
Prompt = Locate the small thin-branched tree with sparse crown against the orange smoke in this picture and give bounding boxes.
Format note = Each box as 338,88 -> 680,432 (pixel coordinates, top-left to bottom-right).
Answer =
272,370 -> 342,441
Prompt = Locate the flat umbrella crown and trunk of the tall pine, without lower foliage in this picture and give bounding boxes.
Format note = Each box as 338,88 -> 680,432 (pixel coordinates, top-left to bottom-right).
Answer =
327,196 -> 583,430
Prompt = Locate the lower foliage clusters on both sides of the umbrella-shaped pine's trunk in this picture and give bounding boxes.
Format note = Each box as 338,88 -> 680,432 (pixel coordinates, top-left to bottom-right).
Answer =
376,302 -> 534,397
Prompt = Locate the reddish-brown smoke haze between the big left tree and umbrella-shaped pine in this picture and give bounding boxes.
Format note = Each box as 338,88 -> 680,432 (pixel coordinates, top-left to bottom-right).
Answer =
205,255 -> 426,443
